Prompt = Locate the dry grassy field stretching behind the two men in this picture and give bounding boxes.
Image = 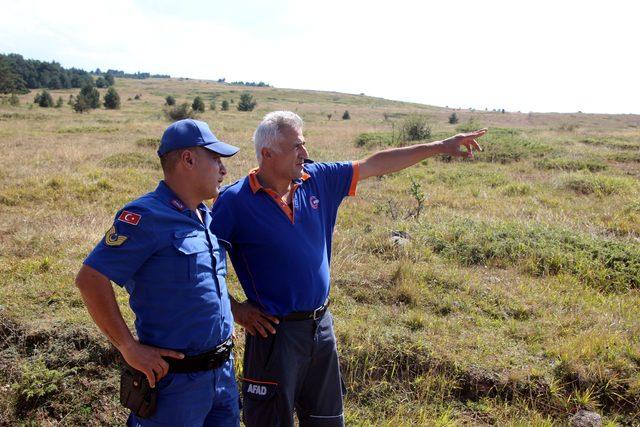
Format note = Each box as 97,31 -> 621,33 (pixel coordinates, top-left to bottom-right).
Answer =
0,79 -> 640,426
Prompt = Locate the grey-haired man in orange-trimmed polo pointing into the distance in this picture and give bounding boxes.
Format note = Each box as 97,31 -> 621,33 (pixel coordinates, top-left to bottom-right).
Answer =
212,111 -> 486,426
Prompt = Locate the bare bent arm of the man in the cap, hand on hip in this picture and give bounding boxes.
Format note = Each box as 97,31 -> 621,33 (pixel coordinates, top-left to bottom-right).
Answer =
76,265 -> 184,387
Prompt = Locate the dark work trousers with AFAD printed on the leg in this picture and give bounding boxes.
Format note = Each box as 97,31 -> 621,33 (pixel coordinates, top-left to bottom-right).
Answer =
242,311 -> 344,427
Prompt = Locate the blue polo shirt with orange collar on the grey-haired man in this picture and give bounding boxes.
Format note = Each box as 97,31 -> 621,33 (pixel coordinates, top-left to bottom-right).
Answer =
211,162 -> 358,316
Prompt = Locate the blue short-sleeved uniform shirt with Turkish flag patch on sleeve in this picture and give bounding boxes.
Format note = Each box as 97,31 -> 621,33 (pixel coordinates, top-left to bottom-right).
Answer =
84,181 -> 233,355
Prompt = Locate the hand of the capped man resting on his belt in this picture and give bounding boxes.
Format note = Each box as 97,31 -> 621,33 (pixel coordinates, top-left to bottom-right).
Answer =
120,341 -> 184,388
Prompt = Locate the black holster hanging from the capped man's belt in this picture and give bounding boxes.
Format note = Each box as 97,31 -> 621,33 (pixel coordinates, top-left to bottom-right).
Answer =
120,363 -> 158,418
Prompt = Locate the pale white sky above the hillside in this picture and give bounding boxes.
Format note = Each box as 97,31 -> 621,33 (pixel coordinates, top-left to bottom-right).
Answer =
0,0 -> 640,114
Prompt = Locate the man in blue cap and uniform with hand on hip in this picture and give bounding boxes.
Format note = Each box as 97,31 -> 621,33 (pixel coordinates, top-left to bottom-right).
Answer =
76,119 -> 239,426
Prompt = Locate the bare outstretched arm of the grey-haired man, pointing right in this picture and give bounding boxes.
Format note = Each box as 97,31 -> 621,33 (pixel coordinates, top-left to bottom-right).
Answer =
358,129 -> 487,180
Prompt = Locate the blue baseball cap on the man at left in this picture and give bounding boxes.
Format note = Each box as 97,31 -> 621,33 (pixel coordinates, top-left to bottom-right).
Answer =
158,119 -> 240,157
